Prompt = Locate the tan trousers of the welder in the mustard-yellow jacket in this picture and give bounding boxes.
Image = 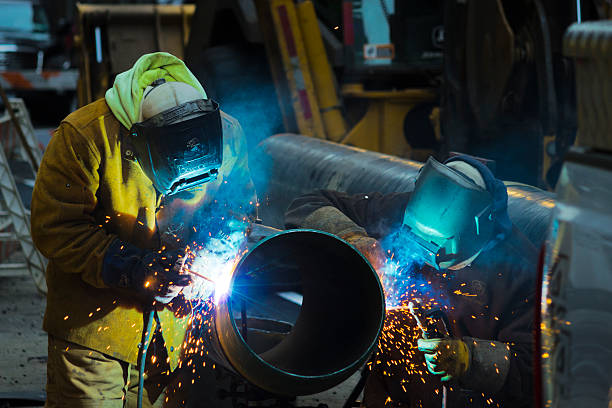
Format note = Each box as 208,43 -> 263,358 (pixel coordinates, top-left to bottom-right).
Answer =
45,335 -> 186,408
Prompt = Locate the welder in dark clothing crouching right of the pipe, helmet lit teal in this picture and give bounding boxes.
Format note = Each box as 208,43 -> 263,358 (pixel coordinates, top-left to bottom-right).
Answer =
286,155 -> 537,408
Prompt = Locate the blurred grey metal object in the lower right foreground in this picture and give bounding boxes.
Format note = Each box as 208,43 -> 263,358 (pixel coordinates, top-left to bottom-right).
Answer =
535,149 -> 612,407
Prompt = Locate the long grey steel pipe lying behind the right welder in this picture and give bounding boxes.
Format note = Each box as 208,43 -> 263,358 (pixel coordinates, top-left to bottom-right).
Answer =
251,134 -> 554,248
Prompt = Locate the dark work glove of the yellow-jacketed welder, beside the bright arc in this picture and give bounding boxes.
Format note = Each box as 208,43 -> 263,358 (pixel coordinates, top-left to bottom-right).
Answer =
102,239 -> 191,303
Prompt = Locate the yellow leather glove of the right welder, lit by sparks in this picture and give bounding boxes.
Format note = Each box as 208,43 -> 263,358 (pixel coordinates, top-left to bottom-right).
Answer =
418,338 -> 470,381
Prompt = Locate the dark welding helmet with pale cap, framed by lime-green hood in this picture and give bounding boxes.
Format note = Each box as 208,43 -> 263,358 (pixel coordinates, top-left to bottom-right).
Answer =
130,79 -> 223,195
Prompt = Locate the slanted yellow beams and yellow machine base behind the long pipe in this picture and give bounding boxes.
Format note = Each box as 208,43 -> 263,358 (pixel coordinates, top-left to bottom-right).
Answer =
256,0 -> 439,157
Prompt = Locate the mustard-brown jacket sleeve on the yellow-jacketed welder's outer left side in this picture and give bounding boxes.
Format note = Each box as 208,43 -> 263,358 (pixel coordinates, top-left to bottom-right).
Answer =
31,122 -> 115,287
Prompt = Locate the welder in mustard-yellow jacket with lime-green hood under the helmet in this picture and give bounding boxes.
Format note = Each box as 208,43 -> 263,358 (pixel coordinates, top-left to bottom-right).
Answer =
31,52 -> 254,407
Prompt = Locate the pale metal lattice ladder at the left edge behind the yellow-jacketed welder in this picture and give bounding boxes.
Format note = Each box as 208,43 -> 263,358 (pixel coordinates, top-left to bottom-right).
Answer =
0,98 -> 47,294
